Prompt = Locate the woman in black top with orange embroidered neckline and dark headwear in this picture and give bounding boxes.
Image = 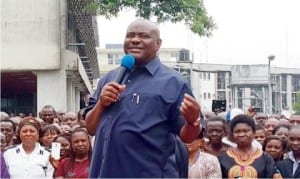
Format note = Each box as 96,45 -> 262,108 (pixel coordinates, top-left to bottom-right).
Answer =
219,114 -> 274,178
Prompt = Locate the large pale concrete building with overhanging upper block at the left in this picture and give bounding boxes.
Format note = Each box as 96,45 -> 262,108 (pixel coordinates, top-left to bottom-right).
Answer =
1,0 -> 99,115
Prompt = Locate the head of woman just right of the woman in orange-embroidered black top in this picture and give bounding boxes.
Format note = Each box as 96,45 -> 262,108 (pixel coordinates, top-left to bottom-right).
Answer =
263,135 -> 287,165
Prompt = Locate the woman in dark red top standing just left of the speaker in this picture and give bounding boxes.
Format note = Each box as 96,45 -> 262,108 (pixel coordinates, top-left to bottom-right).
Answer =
55,128 -> 92,178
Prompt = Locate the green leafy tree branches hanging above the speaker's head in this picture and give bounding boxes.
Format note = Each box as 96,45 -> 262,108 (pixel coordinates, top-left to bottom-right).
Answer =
86,0 -> 216,36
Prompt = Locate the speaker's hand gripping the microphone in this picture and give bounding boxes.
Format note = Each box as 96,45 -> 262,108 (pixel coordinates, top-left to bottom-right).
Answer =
99,82 -> 126,107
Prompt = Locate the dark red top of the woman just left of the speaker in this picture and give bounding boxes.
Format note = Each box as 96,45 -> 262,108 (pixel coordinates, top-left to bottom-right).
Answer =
55,158 -> 90,178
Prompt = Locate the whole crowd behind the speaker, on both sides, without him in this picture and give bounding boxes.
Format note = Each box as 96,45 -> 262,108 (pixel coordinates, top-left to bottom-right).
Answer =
0,105 -> 300,178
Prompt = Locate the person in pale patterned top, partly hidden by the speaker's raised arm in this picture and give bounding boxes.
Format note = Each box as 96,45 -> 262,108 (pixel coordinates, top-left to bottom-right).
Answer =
186,129 -> 222,178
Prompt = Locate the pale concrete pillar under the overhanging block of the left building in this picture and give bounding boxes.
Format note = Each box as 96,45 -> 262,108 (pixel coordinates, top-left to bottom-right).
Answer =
36,70 -> 67,112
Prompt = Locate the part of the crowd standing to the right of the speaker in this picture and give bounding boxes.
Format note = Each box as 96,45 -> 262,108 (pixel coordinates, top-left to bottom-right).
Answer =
187,108 -> 300,178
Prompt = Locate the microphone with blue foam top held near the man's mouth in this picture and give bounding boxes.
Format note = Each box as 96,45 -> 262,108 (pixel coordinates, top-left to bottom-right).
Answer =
114,54 -> 135,84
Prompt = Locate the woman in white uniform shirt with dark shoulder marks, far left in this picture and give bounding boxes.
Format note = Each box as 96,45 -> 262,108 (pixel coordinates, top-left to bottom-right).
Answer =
3,117 -> 54,178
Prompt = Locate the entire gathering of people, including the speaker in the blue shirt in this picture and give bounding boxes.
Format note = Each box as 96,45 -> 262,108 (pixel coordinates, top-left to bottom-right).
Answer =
0,19 -> 300,178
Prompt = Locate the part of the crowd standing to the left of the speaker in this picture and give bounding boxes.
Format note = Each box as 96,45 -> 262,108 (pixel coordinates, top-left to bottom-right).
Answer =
0,105 -> 92,178
